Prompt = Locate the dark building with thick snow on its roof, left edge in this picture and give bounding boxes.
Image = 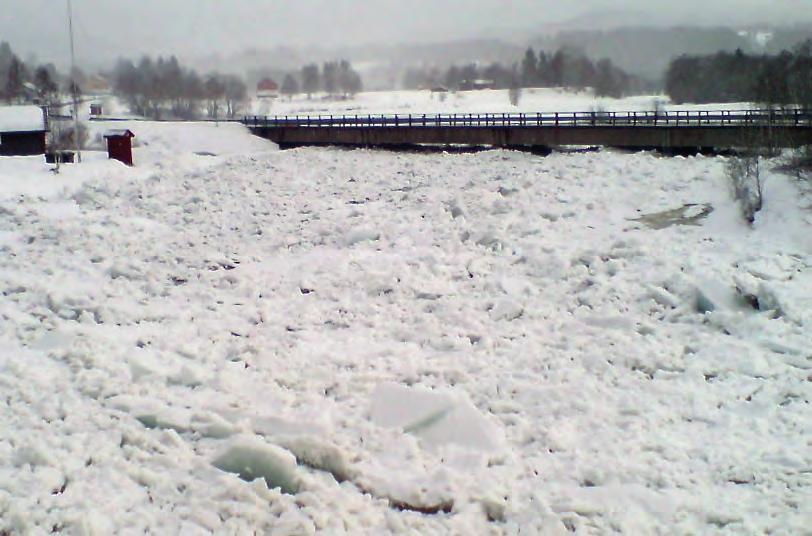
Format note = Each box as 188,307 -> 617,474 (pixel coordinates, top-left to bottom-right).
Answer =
0,106 -> 48,156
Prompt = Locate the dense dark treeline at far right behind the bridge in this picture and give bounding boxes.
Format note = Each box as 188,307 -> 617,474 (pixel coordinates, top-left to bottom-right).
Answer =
665,40 -> 812,107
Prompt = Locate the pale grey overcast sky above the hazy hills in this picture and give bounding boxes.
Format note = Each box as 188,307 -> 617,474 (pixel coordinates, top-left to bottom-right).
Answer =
0,0 -> 812,64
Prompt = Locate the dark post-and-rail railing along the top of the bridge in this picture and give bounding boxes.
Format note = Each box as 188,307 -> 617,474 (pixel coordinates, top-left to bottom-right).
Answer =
243,109 -> 812,128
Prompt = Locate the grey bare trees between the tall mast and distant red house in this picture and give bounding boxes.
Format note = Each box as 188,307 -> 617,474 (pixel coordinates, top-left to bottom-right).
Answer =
112,56 -> 248,119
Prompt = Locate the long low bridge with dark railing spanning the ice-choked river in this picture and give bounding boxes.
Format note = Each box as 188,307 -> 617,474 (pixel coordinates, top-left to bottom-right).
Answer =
242,109 -> 812,152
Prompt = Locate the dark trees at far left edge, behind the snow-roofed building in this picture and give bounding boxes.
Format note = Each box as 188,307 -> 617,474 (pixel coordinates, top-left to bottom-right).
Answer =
0,42 -> 61,104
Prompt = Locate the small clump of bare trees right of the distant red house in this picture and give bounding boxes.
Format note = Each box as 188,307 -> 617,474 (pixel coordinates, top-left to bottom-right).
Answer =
280,60 -> 364,98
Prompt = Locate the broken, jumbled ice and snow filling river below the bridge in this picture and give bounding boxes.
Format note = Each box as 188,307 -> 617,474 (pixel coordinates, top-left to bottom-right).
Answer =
0,119 -> 812,535
